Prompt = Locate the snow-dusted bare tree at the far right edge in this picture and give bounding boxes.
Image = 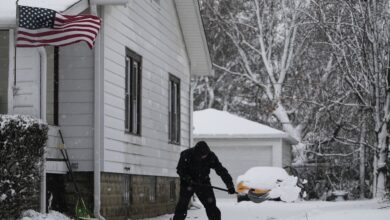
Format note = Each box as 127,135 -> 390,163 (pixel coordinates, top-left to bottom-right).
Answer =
317,0 -> 390,197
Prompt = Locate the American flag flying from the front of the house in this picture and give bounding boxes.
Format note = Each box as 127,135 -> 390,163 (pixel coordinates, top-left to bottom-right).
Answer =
16,6 -> 101,48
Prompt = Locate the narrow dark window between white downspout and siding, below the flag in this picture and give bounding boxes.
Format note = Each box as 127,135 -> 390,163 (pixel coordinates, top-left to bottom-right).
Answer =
46,46 -> 59,125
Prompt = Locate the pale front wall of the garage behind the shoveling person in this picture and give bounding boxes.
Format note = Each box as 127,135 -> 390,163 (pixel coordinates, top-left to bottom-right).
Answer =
194,138 -> 278,198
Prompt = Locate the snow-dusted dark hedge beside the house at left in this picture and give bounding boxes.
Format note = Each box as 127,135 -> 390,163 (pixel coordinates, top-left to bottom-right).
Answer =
0,115 -> 48,219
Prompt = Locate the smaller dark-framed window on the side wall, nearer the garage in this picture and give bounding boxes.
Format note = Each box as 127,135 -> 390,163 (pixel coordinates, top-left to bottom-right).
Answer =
168,75 -> 180,144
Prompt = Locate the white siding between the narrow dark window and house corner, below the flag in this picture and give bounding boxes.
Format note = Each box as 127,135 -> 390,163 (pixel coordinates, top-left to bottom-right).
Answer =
56,43 -> 94,171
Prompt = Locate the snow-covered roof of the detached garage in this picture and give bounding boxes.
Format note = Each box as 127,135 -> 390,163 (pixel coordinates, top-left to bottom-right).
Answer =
193,109 -> 296,142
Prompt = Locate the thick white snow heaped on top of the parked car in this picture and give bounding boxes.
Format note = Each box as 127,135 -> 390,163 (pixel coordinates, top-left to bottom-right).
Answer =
237,167 -> 301,202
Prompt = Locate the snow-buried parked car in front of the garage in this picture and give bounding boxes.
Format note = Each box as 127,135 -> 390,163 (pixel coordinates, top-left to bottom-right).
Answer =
236,167 -> 301,202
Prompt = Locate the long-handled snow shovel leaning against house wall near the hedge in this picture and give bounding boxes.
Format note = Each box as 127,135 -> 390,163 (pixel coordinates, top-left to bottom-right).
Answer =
58,130 -> 94,219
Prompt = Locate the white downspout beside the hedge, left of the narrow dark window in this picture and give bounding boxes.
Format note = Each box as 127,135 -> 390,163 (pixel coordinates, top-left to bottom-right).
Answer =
38,47 -> 47,213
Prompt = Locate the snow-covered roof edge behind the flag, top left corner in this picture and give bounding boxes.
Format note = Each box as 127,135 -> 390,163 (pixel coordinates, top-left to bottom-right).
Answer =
0,0 -> 82,28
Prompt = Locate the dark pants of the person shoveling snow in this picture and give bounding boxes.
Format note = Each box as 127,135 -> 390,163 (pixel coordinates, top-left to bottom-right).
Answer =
173,185 -> 221,220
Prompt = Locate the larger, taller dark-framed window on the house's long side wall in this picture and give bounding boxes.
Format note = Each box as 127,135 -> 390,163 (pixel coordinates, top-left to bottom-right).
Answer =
125,49 -> 142,135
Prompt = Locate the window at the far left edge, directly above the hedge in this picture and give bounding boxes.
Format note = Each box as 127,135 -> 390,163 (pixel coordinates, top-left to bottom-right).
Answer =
0,31 -> 9,114
